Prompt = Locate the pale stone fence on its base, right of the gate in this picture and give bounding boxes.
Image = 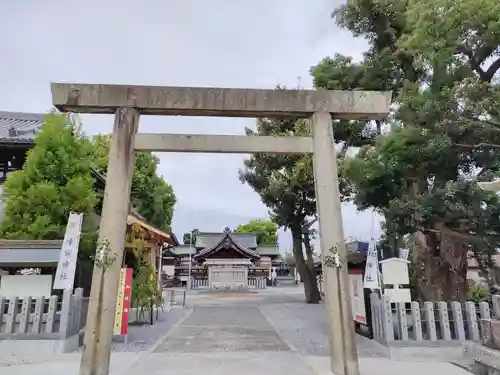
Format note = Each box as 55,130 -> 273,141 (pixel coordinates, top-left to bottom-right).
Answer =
367,293 -> 500,362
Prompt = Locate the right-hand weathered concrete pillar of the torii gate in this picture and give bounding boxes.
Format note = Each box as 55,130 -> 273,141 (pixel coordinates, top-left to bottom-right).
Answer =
311,112 -> 359,375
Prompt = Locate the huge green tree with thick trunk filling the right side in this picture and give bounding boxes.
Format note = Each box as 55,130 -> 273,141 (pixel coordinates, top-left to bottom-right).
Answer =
320,0 -> 500,300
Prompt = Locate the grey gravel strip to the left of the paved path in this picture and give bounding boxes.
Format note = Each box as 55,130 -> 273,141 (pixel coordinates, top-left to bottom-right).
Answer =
112,307 -> 190,352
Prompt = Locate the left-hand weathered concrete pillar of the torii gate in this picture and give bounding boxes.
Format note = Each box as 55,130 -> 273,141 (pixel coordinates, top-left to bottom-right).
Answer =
80,104 -> 139,375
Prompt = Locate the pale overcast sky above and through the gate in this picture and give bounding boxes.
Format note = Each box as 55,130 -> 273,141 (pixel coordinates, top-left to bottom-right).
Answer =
0,0 -> 379,250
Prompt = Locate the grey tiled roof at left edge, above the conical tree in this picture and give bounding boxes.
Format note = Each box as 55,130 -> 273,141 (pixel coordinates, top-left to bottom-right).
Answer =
0,111 -> 45,143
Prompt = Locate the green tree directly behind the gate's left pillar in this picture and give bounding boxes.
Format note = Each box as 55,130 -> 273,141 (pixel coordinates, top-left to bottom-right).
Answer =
92,135 -> 176,230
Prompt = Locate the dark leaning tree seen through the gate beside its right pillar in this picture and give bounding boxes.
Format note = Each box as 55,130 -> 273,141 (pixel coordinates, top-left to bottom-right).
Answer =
239,105 -> 364,303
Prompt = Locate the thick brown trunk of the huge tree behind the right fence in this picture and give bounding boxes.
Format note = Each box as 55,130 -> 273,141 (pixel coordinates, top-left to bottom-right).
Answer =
412,224 -> 467,301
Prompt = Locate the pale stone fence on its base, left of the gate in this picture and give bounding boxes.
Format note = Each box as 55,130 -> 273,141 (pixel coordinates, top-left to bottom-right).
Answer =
0,289 -> 88,355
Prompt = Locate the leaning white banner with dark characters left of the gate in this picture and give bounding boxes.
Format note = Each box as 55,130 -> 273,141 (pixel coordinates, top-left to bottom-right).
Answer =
53,212 -> 83,290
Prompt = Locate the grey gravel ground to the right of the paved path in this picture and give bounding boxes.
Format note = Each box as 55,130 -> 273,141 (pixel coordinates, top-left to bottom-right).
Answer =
259,296 -> 384,357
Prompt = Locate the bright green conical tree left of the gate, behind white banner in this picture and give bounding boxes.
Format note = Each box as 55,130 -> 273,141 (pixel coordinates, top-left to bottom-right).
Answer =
1,114 -> 98,254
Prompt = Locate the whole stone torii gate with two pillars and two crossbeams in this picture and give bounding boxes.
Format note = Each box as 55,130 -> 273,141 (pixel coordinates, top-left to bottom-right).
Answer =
51,83 -> 391,375
